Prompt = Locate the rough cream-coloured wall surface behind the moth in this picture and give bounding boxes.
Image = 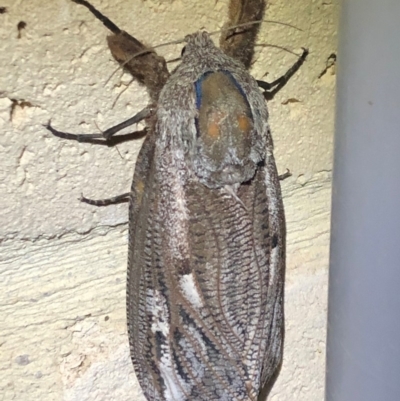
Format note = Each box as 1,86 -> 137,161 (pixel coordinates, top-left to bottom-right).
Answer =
0,0 -> 338,401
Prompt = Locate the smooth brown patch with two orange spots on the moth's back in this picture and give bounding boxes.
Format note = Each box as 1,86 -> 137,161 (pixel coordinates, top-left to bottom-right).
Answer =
196,71 -> 254,184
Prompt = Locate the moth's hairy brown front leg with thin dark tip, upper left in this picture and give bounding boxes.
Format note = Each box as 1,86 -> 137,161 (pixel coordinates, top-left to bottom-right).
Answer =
72,0 -> 169,103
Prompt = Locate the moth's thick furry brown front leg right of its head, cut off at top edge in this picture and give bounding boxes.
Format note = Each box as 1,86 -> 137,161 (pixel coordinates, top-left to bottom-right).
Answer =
219,0 -> 266,68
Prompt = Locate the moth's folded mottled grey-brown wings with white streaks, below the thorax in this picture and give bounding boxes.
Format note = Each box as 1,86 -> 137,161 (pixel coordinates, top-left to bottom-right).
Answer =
127,127 -> 285,401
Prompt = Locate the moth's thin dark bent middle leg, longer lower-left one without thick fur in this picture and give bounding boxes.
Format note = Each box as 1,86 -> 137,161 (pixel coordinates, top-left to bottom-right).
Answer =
45,107 -> 153,146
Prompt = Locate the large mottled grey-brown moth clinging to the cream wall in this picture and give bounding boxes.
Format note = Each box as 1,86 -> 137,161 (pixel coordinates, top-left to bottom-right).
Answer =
47,0 -> 307,401
